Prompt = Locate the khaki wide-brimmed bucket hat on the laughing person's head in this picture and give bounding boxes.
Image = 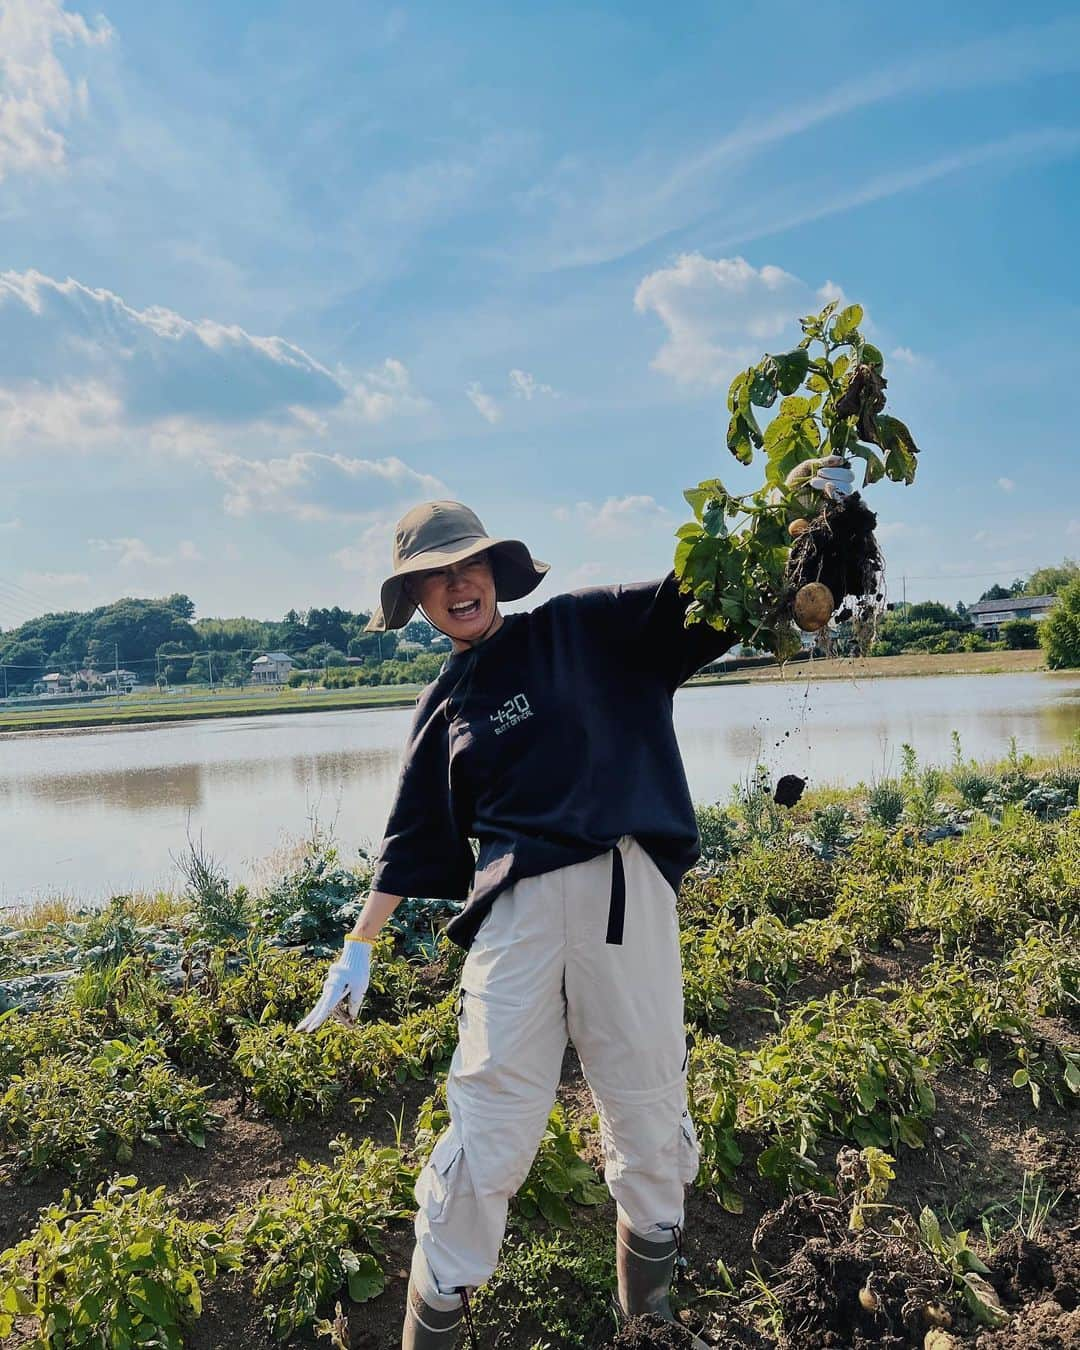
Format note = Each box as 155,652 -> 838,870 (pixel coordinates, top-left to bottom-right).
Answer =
365,502 -> 549,633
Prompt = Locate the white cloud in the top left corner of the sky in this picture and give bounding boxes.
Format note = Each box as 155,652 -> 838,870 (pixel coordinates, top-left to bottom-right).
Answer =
0,0 -> 112,181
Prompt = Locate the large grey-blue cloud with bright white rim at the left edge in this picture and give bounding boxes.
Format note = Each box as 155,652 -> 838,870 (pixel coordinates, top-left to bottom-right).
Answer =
0,271 -> 429,458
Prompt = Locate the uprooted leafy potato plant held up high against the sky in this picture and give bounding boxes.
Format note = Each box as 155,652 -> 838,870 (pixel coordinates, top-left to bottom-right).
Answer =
675,301 -> 918,660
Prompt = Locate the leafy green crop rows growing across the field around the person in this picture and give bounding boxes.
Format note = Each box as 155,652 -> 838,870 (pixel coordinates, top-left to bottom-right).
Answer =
0,752 -> 1080,1350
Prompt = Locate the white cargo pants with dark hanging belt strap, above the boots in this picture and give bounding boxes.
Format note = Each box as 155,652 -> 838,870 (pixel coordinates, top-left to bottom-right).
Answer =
413,834 -> 698,1308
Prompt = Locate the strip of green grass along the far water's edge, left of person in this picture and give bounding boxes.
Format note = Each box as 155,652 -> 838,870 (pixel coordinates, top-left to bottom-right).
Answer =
0,684 -> 421,732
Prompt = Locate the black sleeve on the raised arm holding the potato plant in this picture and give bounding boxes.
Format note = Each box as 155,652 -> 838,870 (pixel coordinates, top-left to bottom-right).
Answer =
578,572 -> 736,690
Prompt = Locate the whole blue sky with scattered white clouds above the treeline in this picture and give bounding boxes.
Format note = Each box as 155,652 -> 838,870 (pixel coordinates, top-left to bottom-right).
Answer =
0,0 -> 1080,629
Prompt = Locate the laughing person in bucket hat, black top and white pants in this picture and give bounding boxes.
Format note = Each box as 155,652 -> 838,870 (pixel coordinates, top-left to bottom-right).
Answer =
300,472 -> 851,1350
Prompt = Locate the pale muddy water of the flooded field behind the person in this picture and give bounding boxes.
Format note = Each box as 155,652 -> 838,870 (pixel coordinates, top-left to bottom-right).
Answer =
0,674 -> 1080,905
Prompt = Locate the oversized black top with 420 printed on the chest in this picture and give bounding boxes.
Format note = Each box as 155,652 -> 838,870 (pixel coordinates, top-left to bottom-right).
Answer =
373,574 -> 732,948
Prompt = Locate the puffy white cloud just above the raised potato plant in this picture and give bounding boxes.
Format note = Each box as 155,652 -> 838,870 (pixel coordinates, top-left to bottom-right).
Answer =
633,254 -> 826,385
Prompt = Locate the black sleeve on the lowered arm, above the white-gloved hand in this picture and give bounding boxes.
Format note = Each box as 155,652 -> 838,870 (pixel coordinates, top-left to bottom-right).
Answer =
371,702 -> 474,900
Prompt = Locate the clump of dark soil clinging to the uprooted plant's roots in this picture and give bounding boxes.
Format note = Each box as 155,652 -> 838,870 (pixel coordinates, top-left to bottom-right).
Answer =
786,493 -> 884,618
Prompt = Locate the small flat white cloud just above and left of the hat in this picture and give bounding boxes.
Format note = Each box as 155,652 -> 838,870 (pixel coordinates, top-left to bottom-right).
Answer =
208,451 -> 447,520
